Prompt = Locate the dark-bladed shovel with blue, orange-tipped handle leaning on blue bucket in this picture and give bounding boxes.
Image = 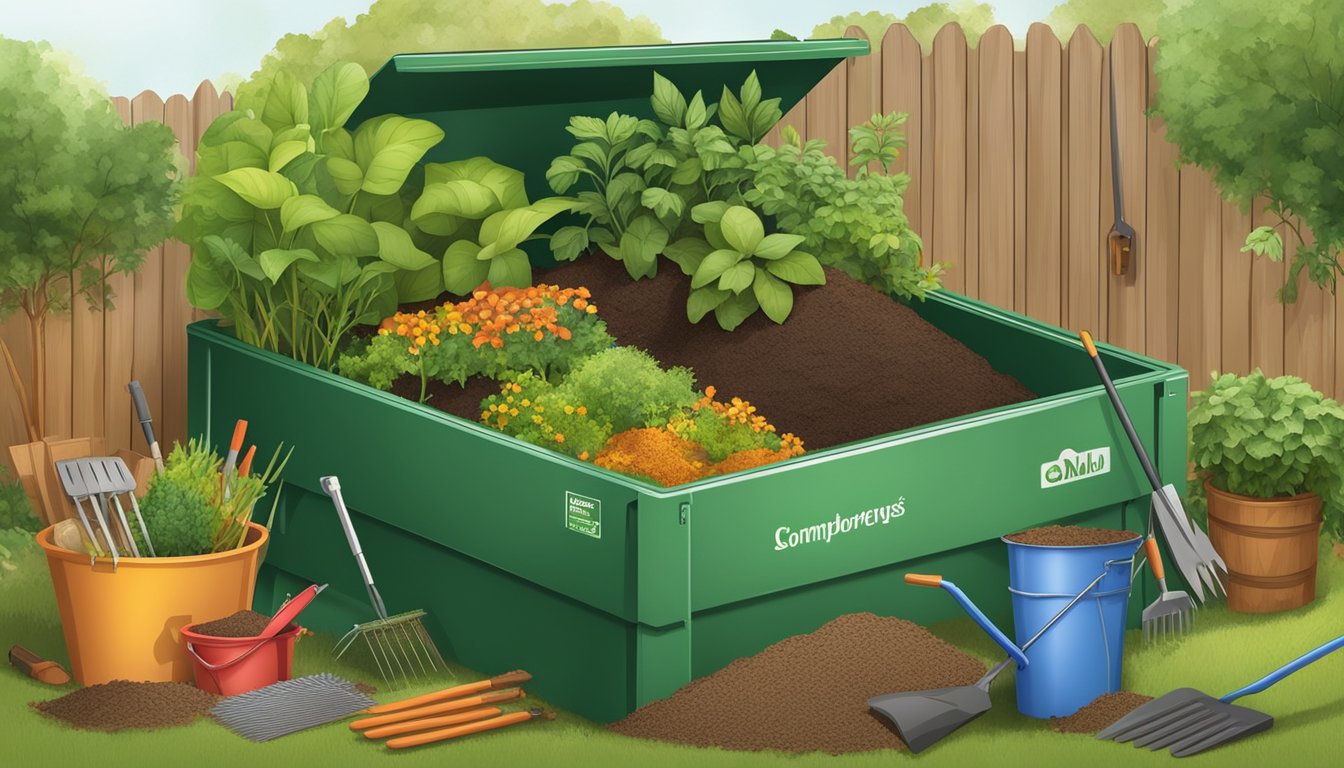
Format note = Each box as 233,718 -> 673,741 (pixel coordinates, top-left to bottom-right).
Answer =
868,562 -> 1113,752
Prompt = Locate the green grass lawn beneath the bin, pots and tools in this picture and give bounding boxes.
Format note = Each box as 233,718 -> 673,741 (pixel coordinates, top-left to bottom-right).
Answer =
0,531 -> 1344,768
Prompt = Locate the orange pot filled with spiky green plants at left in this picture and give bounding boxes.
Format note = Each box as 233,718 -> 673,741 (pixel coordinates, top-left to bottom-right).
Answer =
38,432 -> 289,685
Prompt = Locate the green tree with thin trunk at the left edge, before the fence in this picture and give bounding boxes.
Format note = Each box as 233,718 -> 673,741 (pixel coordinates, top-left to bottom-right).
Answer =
0,38 -> 180,440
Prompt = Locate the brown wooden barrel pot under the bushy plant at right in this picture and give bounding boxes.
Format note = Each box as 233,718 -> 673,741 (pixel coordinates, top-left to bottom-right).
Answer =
1204,480 -> 1321,613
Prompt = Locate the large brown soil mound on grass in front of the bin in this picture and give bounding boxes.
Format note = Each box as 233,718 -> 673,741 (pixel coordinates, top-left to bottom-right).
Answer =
610,613 -> 985,755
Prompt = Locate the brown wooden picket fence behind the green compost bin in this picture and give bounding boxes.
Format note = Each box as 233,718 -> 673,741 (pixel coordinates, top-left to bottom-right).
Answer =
0,24 -> 1344,465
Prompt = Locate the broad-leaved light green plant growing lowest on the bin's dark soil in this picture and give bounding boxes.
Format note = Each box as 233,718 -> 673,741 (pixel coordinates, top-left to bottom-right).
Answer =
667,202 -> 827,331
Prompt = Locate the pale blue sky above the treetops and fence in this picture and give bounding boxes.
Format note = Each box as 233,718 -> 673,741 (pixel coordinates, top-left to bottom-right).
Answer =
0,0 -> 1062,97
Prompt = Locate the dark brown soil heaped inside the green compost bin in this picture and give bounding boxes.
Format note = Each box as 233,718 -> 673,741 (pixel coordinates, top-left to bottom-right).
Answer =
392,259 -> 1035,451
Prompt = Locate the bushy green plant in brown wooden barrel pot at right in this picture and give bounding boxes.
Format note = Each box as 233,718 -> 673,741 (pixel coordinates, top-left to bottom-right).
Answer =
1189,369 -> 1344,613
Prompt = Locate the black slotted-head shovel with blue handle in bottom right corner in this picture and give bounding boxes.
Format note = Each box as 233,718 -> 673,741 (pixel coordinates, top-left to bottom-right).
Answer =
1097,635 -> 1344,757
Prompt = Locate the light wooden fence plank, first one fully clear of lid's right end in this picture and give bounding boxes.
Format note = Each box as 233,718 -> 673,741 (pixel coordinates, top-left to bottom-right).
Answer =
882,24 -> 925,237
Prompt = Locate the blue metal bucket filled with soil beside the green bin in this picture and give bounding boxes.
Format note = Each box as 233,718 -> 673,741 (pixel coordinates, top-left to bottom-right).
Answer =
1003,534 -> 1142,718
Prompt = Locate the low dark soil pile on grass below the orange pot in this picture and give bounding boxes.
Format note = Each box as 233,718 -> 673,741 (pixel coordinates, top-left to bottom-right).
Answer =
32,681 -> 216,730
